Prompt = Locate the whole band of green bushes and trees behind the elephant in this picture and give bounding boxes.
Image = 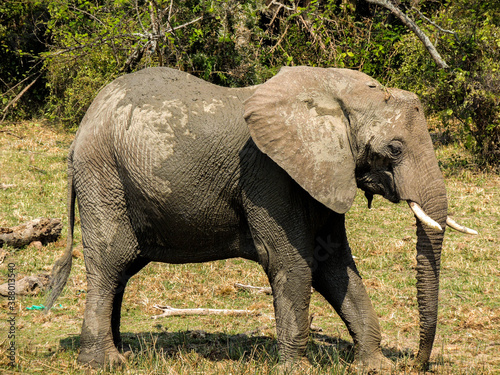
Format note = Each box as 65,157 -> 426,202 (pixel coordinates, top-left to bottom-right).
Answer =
0,0 -> 500,162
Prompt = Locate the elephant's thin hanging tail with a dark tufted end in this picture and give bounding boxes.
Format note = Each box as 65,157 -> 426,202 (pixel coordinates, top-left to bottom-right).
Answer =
45,163 -> 76,313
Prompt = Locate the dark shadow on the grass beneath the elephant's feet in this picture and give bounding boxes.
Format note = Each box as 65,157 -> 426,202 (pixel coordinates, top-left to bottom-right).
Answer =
60,330 -> 410,366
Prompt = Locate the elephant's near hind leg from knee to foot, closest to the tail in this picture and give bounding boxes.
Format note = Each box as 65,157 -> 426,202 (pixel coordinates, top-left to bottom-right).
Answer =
78,217 -> 143,366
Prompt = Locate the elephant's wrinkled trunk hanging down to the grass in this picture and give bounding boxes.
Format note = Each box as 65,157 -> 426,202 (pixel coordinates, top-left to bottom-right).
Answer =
415,184 -> 447,365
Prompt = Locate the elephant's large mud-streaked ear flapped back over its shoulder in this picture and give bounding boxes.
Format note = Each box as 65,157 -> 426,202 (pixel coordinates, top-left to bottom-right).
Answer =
244,67 -> 356,213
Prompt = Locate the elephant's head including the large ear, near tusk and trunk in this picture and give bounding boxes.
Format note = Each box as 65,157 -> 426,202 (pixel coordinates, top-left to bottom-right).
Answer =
245,67 -> 474,363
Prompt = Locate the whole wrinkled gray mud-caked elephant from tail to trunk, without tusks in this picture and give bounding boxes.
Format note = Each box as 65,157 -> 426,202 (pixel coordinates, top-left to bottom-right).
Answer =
47,67 -> 447,368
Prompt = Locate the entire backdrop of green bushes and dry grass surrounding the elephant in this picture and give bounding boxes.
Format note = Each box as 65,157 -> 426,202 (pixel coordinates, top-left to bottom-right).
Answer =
0,0 -> 500,374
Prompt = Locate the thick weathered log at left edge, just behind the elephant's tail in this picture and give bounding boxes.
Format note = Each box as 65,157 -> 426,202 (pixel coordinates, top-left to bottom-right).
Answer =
0,218 -> 62,247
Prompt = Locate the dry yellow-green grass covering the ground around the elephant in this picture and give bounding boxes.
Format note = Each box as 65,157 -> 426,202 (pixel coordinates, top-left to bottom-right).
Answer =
0,122 -> 500,374
